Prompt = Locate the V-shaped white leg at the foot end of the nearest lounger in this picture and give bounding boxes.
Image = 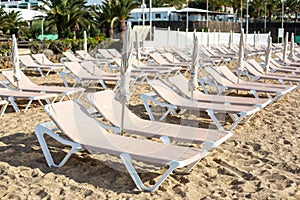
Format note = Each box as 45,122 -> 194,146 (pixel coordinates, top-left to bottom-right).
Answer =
120,153 -> 179,192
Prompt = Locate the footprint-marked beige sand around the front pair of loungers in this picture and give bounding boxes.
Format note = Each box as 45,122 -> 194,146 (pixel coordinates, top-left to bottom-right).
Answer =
0,69 -> 300,199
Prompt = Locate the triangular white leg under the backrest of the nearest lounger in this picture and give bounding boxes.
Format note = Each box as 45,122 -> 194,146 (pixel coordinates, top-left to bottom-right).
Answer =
34,125 -> 83,167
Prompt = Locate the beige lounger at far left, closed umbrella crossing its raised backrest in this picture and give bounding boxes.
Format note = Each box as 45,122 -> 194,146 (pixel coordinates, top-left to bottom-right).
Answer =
2,70 -> 85,101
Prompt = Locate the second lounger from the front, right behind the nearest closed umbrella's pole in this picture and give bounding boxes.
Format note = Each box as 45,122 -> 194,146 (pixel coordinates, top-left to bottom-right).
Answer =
87,90 -> 232,151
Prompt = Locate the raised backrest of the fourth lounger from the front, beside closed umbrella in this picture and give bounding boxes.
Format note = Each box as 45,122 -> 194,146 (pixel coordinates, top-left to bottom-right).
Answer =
169,74 -> 203,98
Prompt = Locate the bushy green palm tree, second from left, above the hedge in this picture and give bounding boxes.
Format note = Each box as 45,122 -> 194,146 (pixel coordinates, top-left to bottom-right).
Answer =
39,0 -> 92,38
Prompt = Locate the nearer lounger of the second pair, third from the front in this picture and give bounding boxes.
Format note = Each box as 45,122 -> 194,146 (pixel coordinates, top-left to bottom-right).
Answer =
141,80 -> 260,131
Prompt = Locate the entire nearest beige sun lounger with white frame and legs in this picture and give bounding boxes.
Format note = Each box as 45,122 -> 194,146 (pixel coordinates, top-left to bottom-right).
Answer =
35,101 -> 208,192
